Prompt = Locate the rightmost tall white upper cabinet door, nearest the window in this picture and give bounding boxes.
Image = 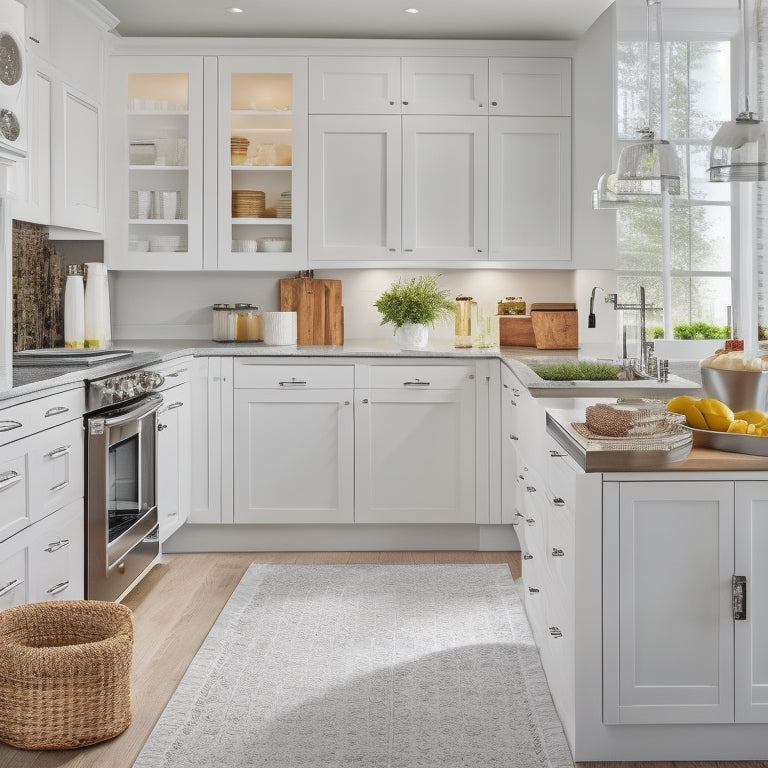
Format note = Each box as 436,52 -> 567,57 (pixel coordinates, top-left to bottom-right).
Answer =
488,117 -> 571,269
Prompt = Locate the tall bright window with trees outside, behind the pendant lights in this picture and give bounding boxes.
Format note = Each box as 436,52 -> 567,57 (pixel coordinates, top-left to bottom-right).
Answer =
616,32 -> 735,338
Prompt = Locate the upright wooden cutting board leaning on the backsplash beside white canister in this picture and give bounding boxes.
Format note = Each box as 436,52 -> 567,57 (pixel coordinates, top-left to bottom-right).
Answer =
280,277 -> 344,346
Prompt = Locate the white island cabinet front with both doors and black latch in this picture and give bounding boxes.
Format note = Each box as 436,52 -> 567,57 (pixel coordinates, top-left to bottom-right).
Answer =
603,478 -> 768,724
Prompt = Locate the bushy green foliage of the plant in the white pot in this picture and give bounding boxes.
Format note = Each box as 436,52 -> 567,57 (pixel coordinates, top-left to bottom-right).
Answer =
373,275 -> 456,328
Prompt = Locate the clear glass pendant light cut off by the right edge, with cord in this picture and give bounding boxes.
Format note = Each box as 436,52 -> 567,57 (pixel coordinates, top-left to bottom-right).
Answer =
707,0 -> 768,181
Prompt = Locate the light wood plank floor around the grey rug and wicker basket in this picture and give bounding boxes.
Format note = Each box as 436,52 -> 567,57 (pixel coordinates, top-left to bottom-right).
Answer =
0,552 -> 768,768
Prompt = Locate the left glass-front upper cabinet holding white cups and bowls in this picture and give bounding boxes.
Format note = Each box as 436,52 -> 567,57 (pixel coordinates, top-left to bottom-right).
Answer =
105,56 -> 204,270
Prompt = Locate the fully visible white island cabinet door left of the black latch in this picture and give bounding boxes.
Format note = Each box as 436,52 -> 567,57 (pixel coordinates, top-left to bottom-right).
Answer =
603,481 -> 734,724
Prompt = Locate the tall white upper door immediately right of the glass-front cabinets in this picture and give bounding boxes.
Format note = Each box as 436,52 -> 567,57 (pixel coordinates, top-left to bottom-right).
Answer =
309,115 -> 403,264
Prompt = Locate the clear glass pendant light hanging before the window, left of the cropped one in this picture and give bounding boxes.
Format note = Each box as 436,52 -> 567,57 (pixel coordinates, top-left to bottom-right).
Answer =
614,0 -> 681,195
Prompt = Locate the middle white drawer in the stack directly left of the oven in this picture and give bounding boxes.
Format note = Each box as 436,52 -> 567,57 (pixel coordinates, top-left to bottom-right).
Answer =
25,420 -> 85,521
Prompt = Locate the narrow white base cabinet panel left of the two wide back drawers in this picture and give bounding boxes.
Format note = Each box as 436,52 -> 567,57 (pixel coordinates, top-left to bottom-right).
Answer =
189,357 -> 233,524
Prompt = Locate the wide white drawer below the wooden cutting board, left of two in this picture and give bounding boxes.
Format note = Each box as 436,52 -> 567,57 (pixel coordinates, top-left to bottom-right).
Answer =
234,360 -> 355,390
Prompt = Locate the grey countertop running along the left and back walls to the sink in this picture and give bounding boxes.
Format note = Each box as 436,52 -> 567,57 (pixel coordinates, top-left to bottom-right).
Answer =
0,339 -> 700,400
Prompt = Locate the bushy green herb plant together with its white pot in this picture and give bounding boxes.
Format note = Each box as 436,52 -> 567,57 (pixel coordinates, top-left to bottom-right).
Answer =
374,275 -> 456,349
